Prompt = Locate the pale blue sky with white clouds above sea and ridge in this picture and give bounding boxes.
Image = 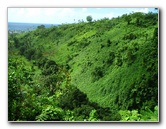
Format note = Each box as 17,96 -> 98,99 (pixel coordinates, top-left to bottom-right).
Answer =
8,8 -> 158,24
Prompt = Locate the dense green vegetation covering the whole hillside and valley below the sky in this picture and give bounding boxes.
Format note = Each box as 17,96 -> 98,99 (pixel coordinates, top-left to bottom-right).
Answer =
8,13 -> 158,121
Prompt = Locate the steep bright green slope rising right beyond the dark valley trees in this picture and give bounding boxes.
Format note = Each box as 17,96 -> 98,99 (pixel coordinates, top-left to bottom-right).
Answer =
10,13 -> 158,113
